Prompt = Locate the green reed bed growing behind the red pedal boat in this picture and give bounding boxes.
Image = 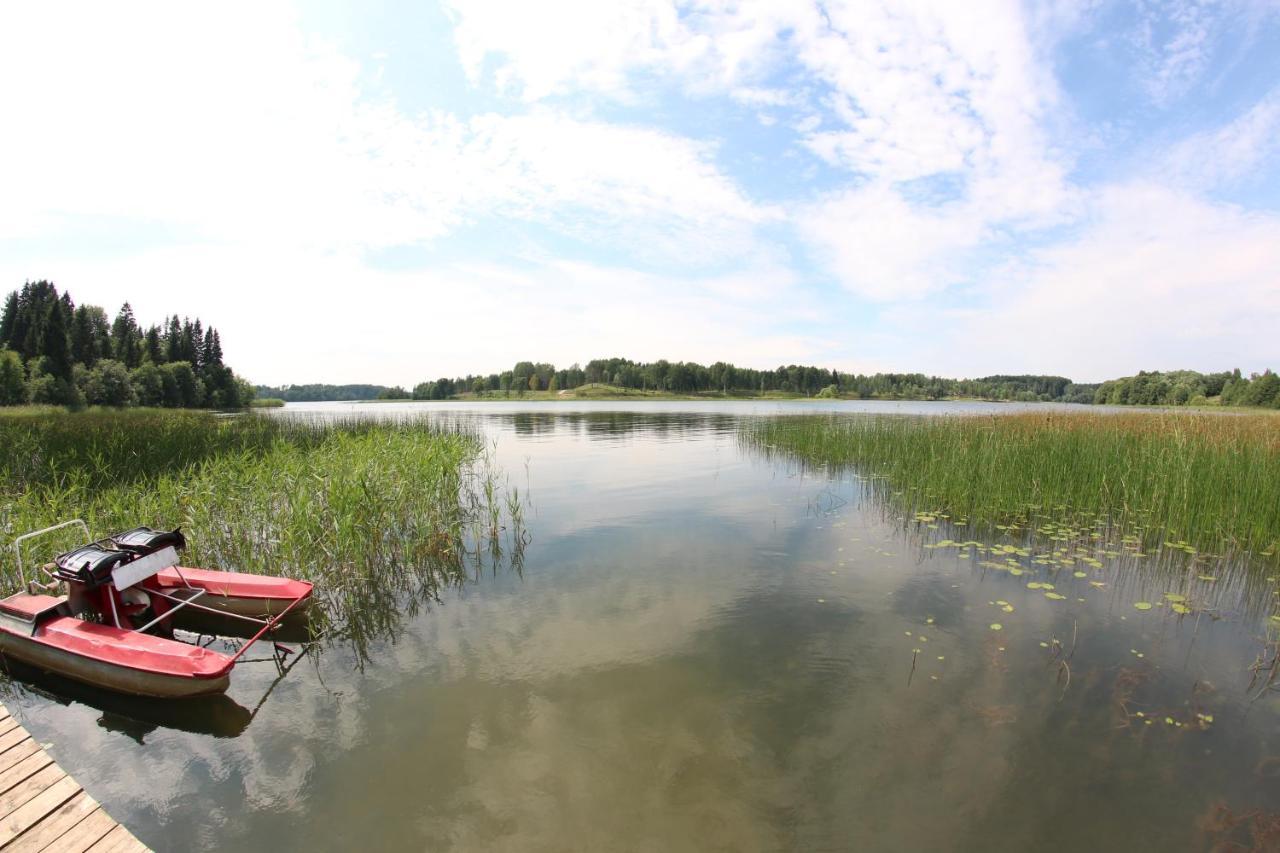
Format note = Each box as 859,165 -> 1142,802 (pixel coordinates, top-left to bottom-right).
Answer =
0,410 -> 522,654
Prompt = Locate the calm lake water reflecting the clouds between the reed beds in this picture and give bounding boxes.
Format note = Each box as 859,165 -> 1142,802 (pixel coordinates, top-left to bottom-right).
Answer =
5,402 -> 1280,852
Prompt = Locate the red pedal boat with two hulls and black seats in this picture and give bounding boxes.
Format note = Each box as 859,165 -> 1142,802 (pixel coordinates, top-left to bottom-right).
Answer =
0,520 -> 311,698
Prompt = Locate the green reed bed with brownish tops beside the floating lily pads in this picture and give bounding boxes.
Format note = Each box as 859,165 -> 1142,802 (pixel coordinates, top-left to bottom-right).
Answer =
741,411 -> 1280,557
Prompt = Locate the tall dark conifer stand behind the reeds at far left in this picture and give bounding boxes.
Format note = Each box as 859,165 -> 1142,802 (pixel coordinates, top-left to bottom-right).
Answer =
0,280 -> 253,409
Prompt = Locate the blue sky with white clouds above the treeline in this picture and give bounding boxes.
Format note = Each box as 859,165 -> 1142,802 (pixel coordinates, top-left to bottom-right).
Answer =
0,0 -> 1280,386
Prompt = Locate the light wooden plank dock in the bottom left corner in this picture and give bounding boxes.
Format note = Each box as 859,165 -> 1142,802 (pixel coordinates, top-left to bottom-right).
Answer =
0,704 -> 147,853
